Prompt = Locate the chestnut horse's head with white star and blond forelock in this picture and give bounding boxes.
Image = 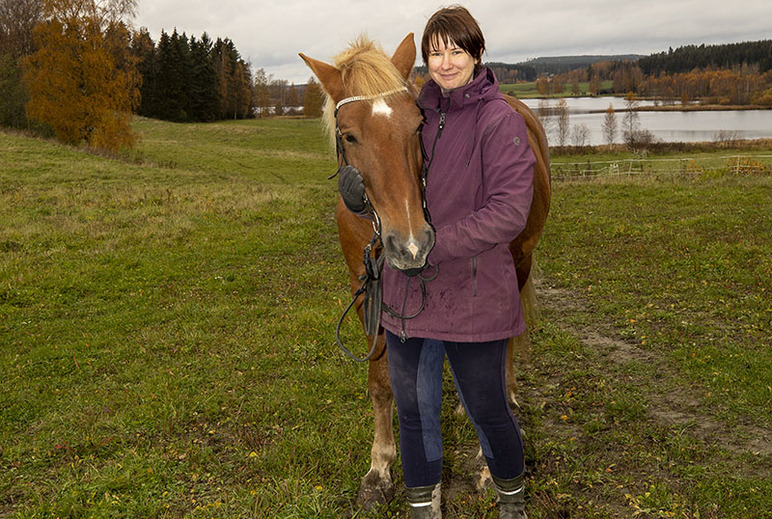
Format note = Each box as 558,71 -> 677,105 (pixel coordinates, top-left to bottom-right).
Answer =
300,33 -> 434,270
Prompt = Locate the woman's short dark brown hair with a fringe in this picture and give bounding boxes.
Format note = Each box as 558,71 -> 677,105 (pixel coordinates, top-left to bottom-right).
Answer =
421,5 -> 485,63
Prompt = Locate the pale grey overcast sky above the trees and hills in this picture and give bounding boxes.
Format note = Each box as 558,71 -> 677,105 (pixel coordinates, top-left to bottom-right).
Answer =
134,0 -> 772,84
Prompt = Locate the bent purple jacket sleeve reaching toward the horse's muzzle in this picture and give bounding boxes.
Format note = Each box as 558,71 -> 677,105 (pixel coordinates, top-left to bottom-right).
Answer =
429,111 -> 536,265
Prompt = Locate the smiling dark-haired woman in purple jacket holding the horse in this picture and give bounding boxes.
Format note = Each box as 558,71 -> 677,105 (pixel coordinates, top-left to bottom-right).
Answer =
340,6 -> 535,518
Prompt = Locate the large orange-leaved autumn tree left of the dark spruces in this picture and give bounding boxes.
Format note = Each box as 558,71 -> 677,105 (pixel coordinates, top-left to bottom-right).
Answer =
25,2 -> 141,151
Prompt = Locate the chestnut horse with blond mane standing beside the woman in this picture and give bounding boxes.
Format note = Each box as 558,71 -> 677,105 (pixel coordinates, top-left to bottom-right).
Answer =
299,33 -> 550,509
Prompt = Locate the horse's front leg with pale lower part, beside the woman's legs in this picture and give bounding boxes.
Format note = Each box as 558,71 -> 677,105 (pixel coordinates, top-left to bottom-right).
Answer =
357,332 -> 397,510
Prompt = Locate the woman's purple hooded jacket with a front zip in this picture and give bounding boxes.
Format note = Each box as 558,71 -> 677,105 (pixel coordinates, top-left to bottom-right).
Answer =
382,68 -> 535,342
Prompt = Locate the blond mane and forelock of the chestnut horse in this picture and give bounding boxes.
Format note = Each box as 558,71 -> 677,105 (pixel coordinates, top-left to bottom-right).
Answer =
322,35 -> 410,143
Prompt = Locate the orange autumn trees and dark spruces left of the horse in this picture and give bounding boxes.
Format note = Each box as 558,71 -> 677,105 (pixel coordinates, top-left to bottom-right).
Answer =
0,0 -> 322,150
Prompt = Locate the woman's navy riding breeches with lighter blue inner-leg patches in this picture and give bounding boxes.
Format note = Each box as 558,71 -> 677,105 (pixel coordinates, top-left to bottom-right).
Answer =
386,331 -> 524,487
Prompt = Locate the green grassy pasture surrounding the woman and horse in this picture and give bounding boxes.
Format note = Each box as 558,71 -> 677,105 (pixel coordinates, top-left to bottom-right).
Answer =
0,119 -> 772,519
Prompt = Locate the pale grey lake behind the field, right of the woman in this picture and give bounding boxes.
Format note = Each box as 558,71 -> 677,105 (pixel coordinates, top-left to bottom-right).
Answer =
523,97 -> 772,146
